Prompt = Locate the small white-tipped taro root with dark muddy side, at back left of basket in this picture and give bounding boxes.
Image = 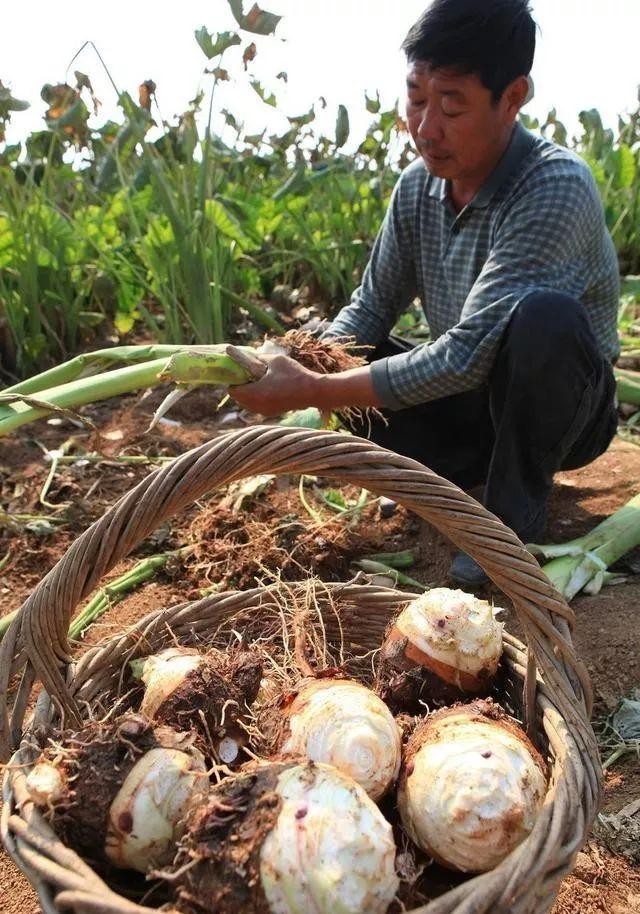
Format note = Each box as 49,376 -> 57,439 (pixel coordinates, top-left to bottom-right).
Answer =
132,647 -> 262,764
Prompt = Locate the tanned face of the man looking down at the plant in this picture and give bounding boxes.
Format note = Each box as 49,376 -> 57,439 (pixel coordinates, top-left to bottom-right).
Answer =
406,63 -> 517,181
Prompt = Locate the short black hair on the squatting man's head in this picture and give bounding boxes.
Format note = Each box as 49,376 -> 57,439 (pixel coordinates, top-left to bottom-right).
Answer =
402,0 -> 536,102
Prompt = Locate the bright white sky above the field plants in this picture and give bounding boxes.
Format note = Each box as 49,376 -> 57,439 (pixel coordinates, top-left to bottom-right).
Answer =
0,0 -> 640,150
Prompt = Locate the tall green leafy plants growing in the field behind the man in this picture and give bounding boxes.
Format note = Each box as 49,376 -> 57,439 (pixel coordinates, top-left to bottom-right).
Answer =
0,7 -> 640,375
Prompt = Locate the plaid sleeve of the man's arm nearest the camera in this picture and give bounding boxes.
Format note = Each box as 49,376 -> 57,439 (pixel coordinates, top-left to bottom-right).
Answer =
372,168 -> 604,409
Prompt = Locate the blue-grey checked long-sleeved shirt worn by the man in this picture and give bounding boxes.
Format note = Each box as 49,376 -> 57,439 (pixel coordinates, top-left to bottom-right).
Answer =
325,123 -> 619,409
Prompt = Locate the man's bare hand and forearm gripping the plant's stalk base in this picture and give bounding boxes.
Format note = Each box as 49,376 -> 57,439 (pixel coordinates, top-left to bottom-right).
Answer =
229,355 -> 380,416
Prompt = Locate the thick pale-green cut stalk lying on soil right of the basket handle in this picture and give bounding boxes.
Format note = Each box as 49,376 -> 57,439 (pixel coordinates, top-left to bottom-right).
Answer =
528,495 -> 640,600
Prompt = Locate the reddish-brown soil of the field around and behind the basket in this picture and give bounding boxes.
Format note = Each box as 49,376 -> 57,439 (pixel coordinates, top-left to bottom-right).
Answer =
0,389 -> 640,914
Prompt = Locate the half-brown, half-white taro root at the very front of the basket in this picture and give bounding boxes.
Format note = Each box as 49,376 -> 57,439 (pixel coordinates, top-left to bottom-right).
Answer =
172,762 -> 398,914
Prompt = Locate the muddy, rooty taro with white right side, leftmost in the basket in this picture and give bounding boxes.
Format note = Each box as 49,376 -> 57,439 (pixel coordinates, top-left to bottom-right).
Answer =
27,714 -> 209,873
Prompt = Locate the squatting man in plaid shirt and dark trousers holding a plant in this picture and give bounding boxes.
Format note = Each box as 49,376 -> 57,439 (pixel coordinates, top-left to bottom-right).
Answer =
234,0 -> 619,587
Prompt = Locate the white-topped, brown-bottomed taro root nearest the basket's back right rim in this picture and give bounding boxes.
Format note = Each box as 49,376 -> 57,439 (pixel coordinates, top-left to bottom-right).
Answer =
377,587 -> 503,713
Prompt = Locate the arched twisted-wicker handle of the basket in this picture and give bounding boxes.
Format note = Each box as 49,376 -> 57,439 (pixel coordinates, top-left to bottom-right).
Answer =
0,426 -> 591,759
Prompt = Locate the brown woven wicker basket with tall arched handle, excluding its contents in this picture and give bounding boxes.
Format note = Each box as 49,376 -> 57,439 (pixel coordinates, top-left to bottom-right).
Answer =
0,427 -> 600,914
